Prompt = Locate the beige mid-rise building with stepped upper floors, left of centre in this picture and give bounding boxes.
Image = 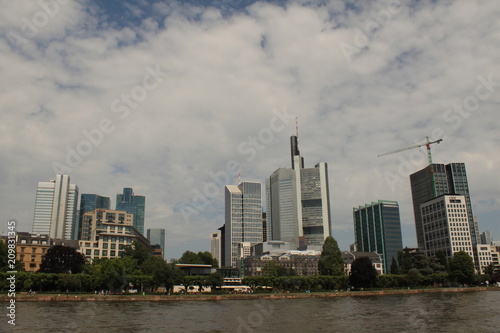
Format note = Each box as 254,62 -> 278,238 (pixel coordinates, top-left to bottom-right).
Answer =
79,209 -> 153,261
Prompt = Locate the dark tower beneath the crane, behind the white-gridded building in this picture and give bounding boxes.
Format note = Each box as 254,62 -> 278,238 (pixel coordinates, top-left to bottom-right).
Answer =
410,163 -> 480,262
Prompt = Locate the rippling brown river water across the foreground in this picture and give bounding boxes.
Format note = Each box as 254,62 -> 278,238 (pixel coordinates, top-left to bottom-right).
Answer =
4,291 -> 500,333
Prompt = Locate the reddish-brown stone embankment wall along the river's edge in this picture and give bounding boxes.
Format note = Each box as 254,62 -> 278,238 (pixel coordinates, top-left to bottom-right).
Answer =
0,287 -> 500,302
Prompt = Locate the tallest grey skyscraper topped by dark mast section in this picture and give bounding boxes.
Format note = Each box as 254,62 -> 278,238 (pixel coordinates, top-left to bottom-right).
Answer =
266,136 -> 330,248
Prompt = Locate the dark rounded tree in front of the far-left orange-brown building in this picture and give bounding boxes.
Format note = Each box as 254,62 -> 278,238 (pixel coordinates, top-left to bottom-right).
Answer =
38,245 -> 85,274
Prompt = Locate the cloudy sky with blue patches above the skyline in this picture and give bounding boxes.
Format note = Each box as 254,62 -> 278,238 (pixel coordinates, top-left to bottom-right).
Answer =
0,0 -> 500,258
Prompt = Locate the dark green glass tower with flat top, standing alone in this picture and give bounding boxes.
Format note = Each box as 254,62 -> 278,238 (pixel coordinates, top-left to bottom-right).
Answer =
353,200 -> 403,273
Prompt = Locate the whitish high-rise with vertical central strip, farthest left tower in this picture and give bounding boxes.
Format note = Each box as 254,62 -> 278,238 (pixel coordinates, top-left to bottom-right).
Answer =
32,175 -> 78,239
